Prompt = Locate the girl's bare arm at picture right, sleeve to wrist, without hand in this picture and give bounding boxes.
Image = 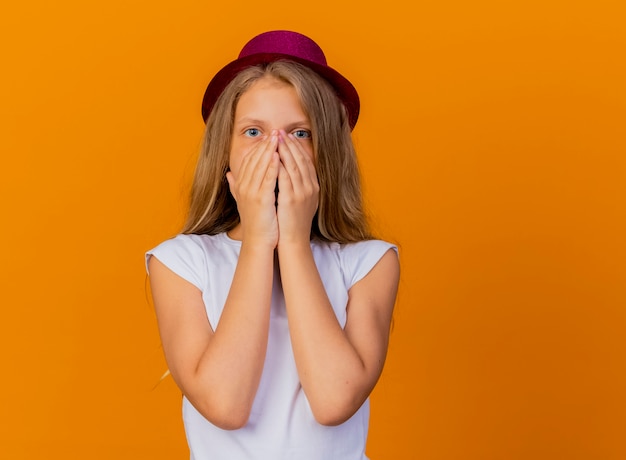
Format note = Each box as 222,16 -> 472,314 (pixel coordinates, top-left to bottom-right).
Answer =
279,244 -> 399,425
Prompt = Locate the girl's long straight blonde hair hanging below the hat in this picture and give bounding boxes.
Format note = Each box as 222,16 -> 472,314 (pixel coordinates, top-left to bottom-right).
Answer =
182,61 -> 372,243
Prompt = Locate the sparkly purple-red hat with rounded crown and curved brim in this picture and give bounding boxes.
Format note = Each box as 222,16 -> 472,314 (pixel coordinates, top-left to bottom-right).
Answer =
197,30 -> 360,128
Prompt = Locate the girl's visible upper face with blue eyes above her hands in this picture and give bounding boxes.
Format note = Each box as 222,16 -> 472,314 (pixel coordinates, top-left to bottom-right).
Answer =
230,77 -> 313,178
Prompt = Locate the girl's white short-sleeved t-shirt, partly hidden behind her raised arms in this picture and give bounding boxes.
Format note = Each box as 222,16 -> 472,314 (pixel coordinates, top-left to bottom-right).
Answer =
146,233 -> 396,460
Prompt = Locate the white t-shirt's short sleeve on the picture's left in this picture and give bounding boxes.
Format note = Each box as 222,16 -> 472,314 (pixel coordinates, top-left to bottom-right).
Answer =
145,235 -> 206,290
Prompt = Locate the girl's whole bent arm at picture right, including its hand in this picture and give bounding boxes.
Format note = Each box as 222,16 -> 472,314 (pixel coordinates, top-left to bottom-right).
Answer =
278,132 -> 399,425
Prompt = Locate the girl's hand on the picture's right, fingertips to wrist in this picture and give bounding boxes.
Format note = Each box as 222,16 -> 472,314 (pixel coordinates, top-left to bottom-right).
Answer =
277,130 -> 320,245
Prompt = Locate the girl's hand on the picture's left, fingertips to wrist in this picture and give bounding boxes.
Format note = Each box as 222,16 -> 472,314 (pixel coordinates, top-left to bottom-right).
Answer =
226,132 -> 280,248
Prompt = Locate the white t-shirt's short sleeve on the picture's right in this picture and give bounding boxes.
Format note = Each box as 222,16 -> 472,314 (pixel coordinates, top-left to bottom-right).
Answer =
341,240 -> 398,289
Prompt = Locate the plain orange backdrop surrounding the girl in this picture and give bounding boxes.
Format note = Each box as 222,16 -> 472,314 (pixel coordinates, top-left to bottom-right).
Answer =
0,0 -> 626,460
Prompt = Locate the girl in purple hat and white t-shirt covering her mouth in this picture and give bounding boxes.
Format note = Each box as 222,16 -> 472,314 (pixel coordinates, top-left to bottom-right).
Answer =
146,31 -> 399,460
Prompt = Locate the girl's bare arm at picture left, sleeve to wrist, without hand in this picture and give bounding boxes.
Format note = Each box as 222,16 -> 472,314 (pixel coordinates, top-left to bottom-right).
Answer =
149,243 -> 274,429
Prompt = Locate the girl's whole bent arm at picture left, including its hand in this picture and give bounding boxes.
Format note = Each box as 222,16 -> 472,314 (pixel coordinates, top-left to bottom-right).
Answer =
149,138 -> 278,429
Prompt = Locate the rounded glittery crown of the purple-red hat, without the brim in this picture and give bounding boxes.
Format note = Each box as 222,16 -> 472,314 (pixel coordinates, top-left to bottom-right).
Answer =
239,30 -> 328,66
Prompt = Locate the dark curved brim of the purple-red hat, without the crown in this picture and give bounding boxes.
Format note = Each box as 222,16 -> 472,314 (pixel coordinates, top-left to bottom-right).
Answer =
202,53 -> 360,129
